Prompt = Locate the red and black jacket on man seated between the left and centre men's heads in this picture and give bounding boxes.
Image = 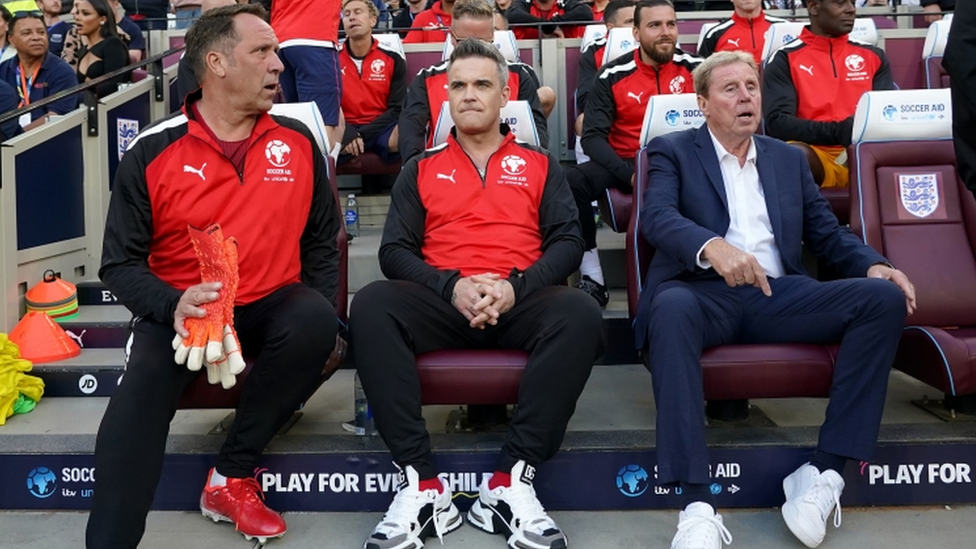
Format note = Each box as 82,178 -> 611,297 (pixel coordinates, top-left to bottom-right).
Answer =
339,38 -> 407,146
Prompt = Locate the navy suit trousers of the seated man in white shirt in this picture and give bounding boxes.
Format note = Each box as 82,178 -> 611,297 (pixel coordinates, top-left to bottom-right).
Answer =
647,275 -> 905,484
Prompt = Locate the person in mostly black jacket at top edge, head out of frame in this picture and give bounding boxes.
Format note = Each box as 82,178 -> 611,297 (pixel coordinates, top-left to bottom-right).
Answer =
506,0 -> 593,40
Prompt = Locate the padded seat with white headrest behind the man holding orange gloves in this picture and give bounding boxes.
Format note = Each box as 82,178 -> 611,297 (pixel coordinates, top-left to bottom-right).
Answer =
177,103 -> 349,410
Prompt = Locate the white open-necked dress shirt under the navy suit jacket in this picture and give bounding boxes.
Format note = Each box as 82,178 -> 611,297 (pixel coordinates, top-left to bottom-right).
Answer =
698,129 -> 785,278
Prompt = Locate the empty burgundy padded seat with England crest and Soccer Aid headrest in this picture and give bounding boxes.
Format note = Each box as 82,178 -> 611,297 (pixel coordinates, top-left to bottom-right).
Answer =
849,90 -> 976,402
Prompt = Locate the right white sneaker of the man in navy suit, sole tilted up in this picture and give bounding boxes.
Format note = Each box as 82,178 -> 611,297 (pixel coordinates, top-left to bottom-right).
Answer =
783,463 -> 844,547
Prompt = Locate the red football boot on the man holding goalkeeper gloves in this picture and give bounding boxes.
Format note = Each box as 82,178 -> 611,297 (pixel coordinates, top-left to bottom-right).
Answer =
200,469 -> 285,544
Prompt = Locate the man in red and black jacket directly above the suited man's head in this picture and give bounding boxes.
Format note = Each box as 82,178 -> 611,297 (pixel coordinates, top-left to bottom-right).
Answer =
698,0 -> 786,65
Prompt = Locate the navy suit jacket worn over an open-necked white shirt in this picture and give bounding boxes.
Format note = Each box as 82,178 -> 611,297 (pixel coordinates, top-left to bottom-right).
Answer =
634,125 -> 885,348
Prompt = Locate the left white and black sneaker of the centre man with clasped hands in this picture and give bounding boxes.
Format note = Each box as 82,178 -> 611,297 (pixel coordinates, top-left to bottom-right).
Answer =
363,465 -> 464,549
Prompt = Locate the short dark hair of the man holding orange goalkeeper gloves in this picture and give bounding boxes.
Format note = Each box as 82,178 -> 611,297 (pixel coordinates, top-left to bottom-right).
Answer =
186,4 -> 268,81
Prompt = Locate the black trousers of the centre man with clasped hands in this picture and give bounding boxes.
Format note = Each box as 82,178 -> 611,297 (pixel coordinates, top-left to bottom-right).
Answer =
349,280 -> 603,479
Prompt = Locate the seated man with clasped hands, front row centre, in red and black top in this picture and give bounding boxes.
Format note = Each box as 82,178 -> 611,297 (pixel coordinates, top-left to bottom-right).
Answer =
349,39 -> 602,549
